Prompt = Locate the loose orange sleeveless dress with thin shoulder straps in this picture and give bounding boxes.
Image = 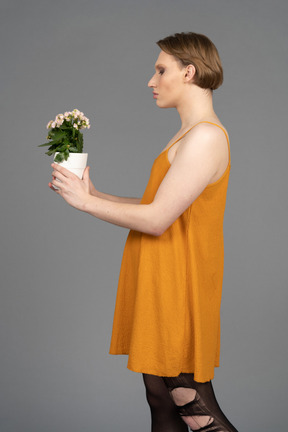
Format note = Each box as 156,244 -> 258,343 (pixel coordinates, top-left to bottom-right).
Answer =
110,122 -> 230,382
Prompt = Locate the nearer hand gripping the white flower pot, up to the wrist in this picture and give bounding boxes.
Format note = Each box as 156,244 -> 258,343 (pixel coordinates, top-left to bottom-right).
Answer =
48,163 -> 91,210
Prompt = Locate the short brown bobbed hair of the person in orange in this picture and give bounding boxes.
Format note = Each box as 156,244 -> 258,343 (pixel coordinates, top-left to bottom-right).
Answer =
157,32 -> 223,90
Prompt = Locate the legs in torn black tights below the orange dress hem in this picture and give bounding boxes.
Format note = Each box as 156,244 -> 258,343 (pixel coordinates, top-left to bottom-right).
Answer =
143,374 -> 237,432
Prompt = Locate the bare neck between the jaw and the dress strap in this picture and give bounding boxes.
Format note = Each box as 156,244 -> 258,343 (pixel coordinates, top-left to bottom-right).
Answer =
176,86 -> 216,130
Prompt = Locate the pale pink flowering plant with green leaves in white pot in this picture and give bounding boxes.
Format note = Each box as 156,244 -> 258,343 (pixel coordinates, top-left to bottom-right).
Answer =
39,109 -> 90,178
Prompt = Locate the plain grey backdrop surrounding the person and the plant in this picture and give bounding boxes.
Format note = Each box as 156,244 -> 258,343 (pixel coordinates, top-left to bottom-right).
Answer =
0,0 -> 288,432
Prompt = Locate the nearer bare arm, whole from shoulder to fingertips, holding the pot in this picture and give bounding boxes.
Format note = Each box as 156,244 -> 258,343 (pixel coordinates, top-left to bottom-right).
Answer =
50,124 -> 227,236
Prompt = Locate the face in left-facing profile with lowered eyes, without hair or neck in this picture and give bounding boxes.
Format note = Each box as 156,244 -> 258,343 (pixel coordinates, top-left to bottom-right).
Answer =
148,51 -> 185,108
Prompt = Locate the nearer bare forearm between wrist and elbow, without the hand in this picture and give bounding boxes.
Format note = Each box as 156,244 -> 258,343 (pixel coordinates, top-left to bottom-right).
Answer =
81,196 -> 162,236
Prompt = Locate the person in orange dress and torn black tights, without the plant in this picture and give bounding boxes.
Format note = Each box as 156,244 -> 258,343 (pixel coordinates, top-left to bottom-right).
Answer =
49,32 -> 237,432
